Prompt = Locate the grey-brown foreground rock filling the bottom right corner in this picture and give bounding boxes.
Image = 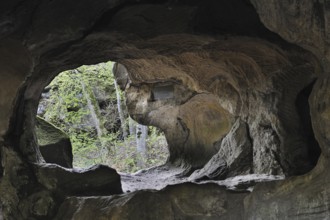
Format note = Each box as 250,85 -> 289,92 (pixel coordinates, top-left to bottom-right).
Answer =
244,158 -> 330,220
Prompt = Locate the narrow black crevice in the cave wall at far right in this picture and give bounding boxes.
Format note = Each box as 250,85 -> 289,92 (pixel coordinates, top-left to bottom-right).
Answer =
296,81 -> 321,167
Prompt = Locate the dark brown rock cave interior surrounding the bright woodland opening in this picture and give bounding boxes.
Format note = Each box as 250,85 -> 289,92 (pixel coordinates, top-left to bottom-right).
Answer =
0,0 -> 330,220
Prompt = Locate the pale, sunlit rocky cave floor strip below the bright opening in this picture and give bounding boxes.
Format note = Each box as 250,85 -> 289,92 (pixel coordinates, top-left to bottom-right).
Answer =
119,164 -> 284,193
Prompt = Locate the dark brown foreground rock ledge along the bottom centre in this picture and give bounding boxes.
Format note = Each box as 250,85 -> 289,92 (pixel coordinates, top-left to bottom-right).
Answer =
56,183 -> 247,220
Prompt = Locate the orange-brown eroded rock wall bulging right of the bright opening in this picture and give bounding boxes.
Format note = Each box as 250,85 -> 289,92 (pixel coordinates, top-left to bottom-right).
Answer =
116,36 -> 318,175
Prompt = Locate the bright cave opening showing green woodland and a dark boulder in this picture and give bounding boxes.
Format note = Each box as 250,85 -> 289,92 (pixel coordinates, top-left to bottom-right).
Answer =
36,62 -> 168,173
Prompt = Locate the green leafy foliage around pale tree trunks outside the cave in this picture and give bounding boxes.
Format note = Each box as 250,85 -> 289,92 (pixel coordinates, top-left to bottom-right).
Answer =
39,62 -> 168,172
